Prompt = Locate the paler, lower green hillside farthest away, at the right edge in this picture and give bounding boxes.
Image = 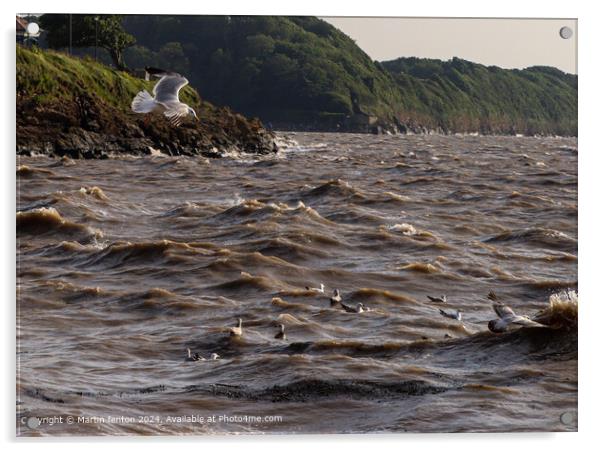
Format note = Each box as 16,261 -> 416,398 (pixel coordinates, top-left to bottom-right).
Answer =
382,58 -> 577,135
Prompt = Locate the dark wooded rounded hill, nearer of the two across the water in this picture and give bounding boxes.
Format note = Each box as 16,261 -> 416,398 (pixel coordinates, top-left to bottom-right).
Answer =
119,16 -> 400,124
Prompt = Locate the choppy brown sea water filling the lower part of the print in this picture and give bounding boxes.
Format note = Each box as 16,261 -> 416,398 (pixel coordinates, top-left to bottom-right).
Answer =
16,133 -> 577,436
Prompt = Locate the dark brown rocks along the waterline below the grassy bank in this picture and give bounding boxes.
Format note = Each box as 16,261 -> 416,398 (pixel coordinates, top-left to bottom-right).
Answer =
17,102 -> 278,159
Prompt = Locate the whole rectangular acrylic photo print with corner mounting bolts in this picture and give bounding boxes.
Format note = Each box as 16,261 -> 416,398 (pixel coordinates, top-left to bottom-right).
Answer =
16,14 -> 577,436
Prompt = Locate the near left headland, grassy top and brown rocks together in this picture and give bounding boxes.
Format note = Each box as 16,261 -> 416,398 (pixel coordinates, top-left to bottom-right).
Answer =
16,45 -> 277,158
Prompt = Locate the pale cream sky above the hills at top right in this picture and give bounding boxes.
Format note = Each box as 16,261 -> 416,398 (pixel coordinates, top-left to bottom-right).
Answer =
322,17 -> 577,74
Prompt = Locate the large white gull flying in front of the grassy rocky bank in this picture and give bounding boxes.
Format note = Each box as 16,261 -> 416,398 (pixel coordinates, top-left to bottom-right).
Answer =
132,67 -> 198,127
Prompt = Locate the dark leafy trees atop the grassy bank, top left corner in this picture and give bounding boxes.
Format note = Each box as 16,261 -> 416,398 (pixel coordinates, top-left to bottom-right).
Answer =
40,14 -> 136,70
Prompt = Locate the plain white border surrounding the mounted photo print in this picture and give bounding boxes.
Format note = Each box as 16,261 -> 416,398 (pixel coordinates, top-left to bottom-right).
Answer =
0,0 -> 602,451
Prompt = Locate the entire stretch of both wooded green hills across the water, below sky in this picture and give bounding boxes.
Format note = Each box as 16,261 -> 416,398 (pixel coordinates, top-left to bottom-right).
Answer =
38,15 -> 577,135
